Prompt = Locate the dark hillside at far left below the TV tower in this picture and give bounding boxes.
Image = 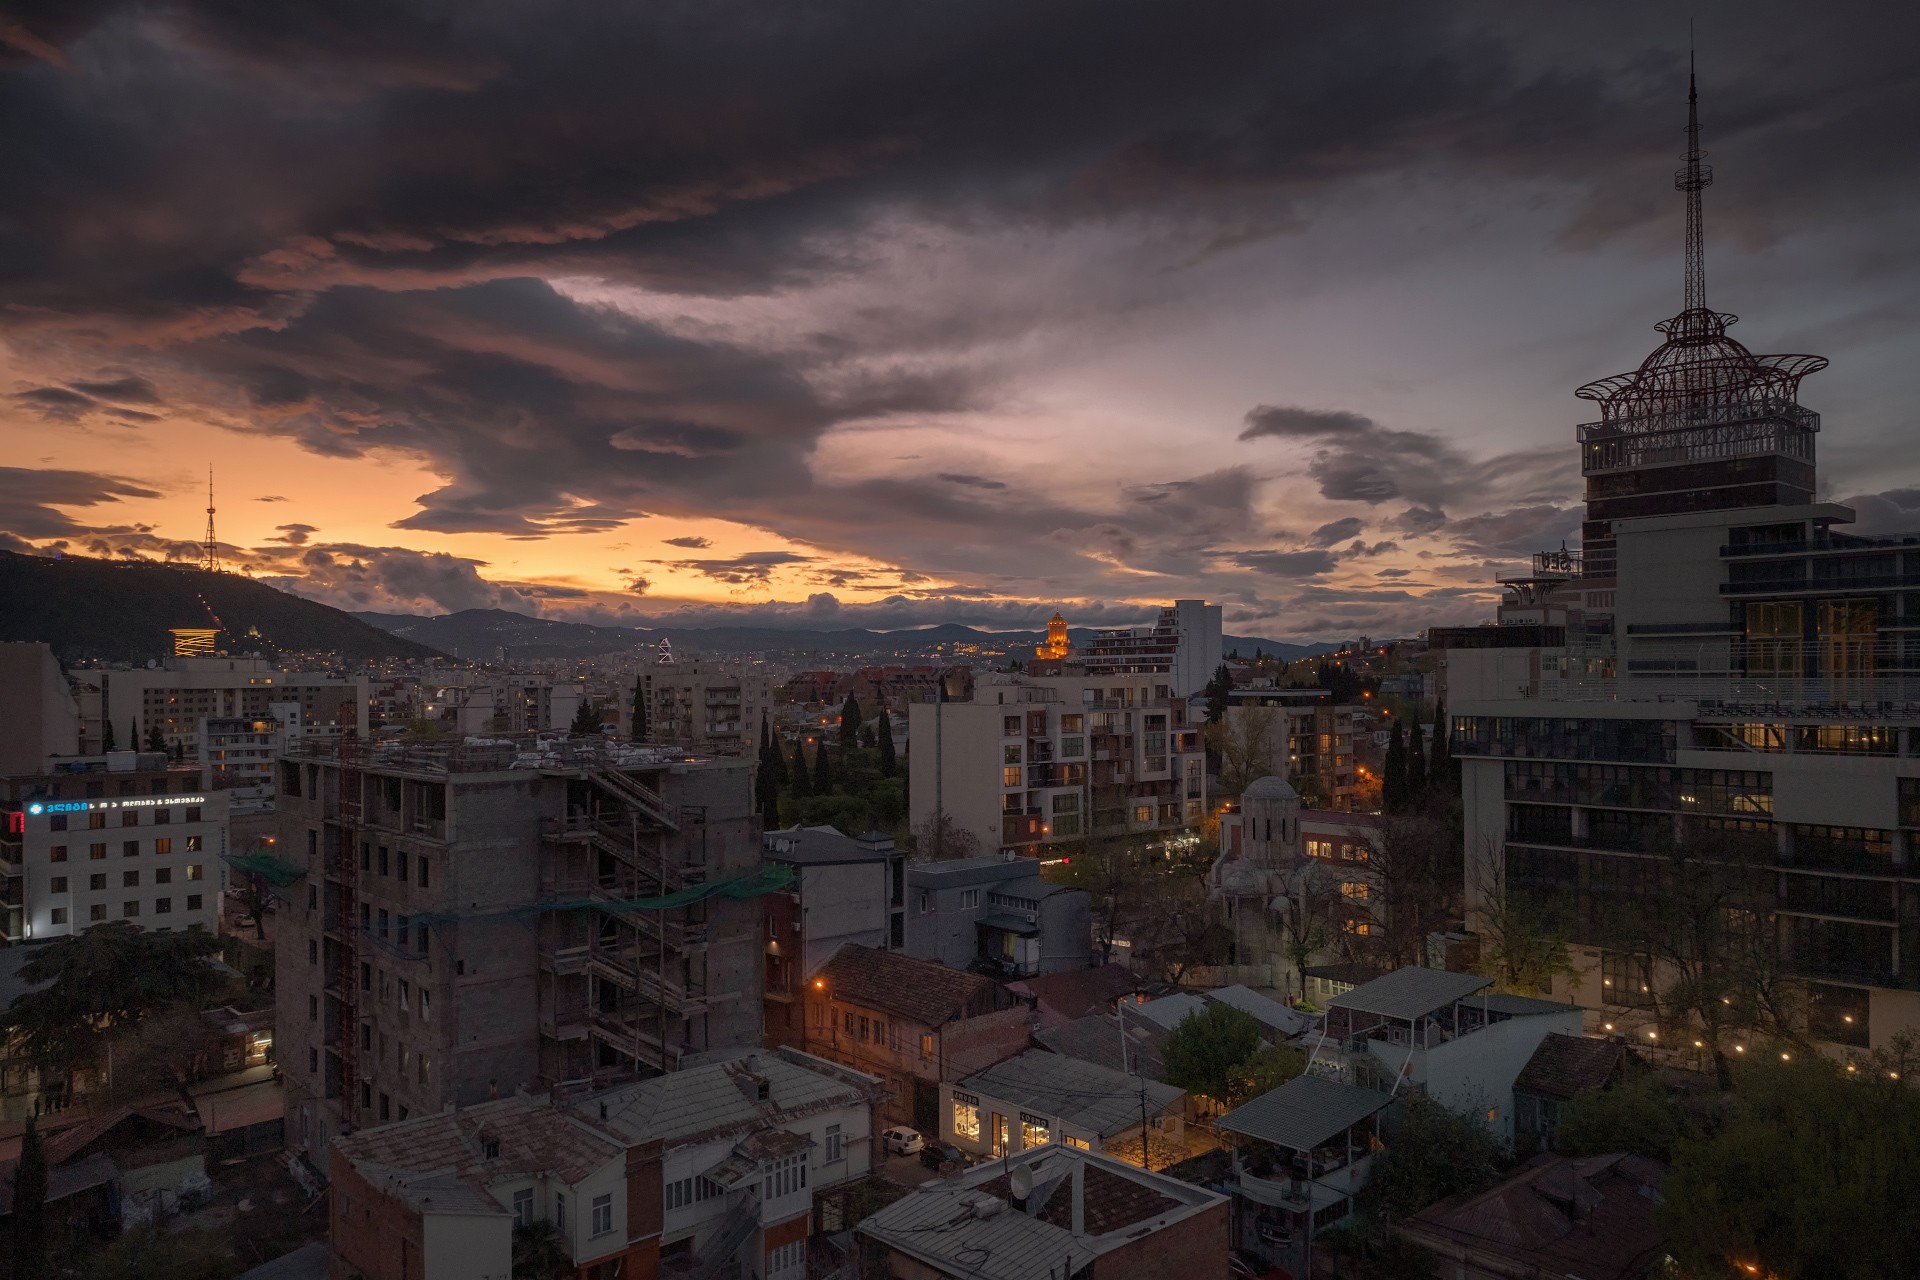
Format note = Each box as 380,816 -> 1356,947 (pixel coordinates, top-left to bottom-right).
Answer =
0,551 -> 438,662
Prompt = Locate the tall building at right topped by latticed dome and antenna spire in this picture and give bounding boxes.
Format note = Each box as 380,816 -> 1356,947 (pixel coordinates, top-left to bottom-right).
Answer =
1432,80 -> 1920,1055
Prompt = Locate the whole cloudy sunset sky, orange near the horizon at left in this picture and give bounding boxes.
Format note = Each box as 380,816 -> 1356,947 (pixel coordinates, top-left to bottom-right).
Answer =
0,0 -> 1920,637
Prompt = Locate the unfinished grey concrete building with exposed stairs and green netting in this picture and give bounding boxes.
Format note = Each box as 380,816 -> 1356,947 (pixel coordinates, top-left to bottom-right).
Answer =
276,737 -> 764,1167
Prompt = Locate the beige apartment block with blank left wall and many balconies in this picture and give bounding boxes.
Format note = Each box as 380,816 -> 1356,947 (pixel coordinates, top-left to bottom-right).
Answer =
908,674 -> 1206,856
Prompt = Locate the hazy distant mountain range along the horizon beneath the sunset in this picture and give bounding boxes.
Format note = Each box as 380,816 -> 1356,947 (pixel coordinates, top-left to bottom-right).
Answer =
353,608 -> 1338,662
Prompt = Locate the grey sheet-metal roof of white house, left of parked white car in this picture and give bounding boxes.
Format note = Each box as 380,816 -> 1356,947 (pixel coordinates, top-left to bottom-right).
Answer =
566,1050 -> 879,1146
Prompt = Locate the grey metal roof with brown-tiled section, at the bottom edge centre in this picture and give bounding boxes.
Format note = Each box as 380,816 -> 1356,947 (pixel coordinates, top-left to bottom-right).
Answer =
858,1144 -> 1227,1280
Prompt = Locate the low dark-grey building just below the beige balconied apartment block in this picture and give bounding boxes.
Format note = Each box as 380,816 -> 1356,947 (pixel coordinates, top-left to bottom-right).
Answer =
906,854 -> 1092,979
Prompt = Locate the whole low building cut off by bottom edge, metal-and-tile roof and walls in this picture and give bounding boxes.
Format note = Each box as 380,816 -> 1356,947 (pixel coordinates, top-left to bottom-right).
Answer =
856,1144 -> 1229,1280
